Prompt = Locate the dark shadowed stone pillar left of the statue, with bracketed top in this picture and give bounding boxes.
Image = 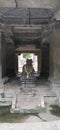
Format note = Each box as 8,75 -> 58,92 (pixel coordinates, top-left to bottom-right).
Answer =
5,31 -> 15,76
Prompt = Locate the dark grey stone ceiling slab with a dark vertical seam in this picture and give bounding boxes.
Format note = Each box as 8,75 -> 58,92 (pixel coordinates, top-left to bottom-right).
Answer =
0,7 -> 54,25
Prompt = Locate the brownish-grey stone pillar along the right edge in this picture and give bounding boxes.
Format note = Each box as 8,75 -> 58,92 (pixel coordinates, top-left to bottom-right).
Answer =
50,22 -> 60,89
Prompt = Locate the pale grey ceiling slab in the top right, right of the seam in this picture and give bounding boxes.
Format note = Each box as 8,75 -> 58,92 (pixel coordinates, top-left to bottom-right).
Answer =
17,0 -> 59,8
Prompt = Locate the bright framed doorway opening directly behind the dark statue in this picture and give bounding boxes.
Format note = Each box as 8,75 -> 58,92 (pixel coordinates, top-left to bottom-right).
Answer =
15,47 -> 41,76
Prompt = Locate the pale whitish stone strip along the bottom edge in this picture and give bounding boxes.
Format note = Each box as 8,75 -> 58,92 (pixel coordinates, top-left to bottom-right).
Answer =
0,121 -> 60,130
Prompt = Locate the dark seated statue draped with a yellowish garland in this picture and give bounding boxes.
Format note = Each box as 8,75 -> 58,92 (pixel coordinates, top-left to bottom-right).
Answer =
21,59 -> 35,83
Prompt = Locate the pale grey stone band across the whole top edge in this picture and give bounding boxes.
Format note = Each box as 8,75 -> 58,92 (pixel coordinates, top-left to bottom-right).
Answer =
0,0 -> 60,9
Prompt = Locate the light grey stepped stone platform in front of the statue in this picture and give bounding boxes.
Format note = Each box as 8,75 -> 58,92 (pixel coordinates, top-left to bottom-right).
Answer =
11,84 -> 45,113
